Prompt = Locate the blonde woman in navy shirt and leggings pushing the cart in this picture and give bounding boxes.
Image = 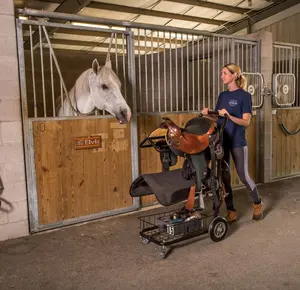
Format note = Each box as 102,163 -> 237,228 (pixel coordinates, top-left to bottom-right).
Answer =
202,63 -> 264,222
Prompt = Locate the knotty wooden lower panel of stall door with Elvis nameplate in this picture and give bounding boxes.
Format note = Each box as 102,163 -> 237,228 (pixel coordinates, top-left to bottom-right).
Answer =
33,118 -> 133,225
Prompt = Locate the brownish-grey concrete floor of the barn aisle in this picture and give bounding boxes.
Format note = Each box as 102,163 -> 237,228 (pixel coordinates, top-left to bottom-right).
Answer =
0,178 -> 300,290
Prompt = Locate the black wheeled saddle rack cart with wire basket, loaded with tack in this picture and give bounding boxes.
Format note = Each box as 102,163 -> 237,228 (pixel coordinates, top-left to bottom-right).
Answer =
130,111 -> 229,258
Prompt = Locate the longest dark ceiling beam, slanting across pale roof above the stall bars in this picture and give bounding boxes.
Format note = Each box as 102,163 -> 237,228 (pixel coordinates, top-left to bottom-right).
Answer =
87,2 -> 228,26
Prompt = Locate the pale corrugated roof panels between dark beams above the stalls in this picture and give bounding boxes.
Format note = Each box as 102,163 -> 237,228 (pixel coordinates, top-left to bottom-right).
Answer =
17,0 -> 282,51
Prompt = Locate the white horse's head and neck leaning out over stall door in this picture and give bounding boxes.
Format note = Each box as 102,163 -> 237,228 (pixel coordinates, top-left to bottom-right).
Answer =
58,59 -> 131,124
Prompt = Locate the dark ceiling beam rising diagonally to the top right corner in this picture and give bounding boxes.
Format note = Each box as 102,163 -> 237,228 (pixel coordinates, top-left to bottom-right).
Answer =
216,0 -> 299,35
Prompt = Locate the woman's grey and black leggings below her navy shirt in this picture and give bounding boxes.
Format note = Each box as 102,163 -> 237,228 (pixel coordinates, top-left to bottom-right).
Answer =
223,146 -> 260,210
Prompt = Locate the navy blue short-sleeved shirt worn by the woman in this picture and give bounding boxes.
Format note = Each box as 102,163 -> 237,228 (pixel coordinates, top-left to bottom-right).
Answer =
215,89 -> 252,148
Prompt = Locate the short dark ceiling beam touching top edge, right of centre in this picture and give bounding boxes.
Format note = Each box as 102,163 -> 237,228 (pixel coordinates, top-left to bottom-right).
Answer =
164,0 -> 251,14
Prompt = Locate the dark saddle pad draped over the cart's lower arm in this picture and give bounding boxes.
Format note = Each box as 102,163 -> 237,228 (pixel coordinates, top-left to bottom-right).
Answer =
130,169 -> 193,206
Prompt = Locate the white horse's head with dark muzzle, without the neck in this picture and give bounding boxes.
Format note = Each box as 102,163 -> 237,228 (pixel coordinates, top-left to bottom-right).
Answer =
89,59 -> 131,124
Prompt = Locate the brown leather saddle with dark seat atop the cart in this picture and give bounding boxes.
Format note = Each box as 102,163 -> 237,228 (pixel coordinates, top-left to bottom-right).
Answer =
160,117 -> 216,154
